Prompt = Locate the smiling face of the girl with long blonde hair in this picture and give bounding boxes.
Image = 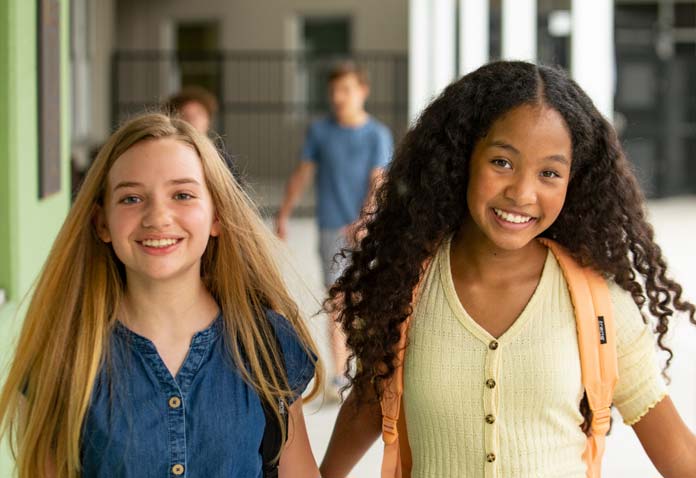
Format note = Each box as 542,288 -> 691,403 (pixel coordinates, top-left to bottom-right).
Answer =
97,138 -> 219,284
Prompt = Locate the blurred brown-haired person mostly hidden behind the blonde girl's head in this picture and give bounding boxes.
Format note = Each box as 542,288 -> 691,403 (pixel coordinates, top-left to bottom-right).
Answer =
164,85 -> 242,184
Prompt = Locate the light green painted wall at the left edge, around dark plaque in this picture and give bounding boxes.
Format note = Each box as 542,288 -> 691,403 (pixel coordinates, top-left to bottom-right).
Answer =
0,0 -> 70,477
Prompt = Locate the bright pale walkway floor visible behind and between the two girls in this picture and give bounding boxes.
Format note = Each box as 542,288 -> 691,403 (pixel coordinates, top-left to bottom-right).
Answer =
270,197 -> 696,478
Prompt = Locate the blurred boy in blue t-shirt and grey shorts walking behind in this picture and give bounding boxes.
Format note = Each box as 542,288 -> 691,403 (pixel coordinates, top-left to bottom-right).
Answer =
276,62 -> 393,401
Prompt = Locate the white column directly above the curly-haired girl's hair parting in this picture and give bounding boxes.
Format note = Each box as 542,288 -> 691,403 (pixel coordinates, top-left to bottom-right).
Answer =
501,0 -> 540,62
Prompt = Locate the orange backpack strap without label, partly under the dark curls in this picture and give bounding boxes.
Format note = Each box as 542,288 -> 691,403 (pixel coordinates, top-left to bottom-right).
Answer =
380,259 -> 431,478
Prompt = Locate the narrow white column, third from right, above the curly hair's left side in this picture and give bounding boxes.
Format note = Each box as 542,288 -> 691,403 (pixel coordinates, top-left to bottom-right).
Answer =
459,0 -> 490,75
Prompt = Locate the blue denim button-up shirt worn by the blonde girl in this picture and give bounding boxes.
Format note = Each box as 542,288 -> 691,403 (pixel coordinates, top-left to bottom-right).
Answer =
81,311 -> 314,478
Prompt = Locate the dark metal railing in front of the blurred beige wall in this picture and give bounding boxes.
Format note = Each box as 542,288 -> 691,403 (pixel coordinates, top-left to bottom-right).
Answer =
112,51 -> 408,208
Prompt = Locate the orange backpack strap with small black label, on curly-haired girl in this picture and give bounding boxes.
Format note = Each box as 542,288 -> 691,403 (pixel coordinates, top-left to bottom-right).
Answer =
540,239 -> 618,478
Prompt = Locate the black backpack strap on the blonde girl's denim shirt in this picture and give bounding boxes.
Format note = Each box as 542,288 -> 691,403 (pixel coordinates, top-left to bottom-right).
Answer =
259,324 -> 288,478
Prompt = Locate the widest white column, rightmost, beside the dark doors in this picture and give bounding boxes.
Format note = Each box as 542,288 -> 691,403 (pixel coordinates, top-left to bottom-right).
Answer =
570,0 -> 616,120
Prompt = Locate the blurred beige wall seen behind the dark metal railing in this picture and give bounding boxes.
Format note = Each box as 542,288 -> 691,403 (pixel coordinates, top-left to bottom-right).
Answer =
109,0 -> 408,179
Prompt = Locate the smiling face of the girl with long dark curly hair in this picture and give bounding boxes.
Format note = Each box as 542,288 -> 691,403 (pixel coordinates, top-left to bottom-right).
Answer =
463,105 -> 572,251
